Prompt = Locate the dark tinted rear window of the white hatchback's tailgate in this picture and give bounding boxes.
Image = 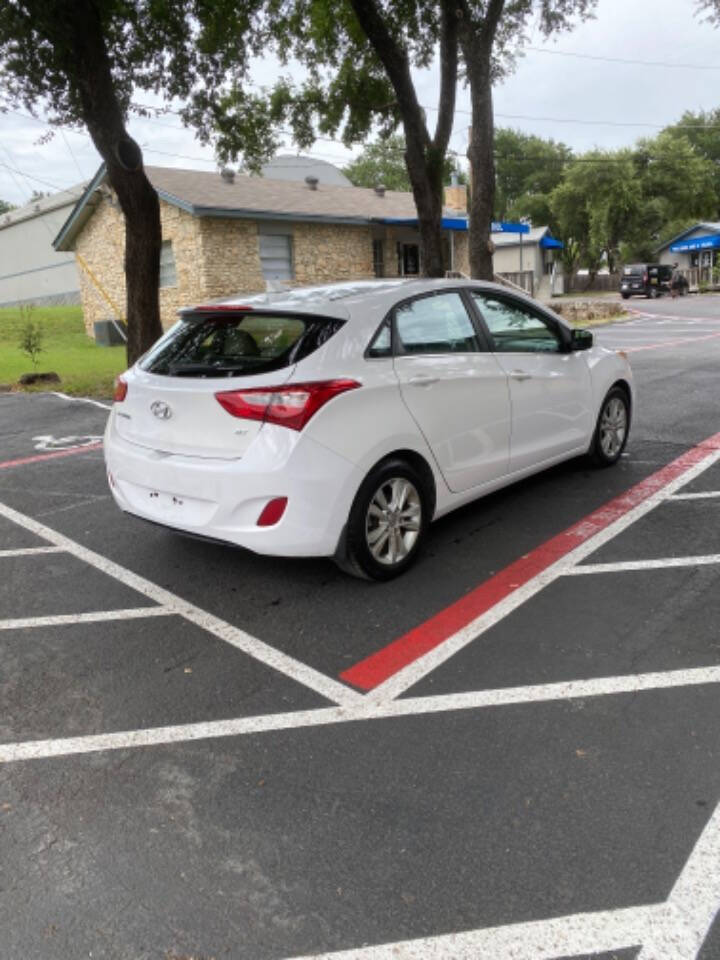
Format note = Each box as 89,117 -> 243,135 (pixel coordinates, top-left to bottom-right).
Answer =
140,313 -> 342,377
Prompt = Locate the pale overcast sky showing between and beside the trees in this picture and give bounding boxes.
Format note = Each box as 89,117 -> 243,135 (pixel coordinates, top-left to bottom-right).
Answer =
0,0 -> 720,204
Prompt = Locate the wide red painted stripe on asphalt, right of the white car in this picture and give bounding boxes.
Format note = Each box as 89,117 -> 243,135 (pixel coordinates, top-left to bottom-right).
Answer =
340,433 -> 720,690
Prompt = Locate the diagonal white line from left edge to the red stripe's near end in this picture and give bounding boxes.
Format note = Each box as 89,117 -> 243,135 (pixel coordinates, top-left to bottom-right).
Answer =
0,503 -> 364,704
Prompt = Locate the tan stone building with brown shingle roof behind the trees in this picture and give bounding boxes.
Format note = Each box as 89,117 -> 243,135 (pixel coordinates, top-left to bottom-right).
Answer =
54,167 -> 468,333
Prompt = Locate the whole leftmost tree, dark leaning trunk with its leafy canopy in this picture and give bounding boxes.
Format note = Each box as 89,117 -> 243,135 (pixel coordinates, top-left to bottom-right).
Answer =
0,0 -> 264,362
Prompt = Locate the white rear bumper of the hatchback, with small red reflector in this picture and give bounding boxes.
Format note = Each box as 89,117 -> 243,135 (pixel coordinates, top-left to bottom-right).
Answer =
105,415 -> 362,556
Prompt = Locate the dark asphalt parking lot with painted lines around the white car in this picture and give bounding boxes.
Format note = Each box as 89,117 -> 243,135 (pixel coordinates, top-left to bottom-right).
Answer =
0,296 -> 720,960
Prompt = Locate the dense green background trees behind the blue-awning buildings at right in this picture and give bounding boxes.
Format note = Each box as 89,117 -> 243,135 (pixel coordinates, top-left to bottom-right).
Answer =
495,119 -> 720,270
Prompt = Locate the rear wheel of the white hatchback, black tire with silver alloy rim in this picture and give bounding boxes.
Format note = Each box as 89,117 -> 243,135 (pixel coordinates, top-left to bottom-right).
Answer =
335,457 -> 432,580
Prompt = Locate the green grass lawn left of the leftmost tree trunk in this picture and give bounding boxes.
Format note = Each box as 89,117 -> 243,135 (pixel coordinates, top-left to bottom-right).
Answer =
0,306 -> 127,397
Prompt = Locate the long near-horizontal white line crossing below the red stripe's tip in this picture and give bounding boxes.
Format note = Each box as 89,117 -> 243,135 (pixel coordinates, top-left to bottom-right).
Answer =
0,666 -> 720,763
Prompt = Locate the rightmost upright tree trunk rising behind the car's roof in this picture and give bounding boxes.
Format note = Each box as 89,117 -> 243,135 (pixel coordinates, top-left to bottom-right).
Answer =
465,56 -> 495,280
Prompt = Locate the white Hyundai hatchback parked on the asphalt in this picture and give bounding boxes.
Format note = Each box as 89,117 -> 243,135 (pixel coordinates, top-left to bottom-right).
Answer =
105,280 -> 633,580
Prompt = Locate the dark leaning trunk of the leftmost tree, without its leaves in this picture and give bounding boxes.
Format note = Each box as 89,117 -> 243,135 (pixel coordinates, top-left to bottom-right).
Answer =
64,0 -> 162,365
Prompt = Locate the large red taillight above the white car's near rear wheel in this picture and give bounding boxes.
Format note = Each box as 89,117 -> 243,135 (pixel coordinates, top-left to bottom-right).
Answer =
215,380 -> 360,430
